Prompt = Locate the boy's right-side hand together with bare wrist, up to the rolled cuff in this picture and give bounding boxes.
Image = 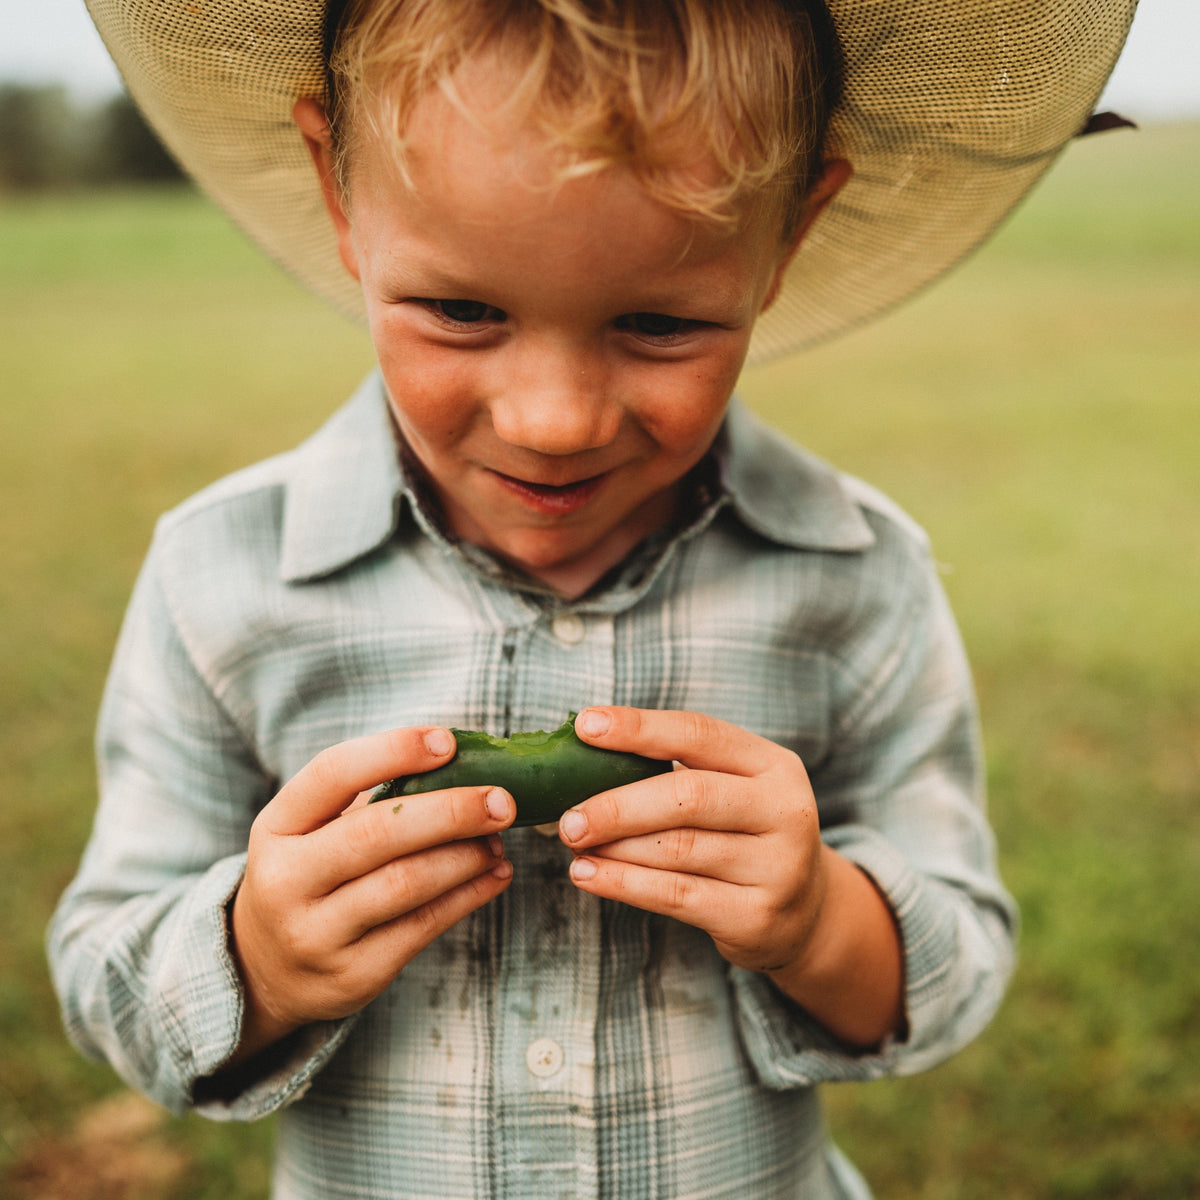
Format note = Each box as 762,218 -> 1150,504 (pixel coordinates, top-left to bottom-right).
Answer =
559,707 -> 904,1046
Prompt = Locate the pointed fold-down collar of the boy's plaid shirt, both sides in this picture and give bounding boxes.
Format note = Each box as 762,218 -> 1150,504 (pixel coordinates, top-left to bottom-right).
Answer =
280,372 -> 875,583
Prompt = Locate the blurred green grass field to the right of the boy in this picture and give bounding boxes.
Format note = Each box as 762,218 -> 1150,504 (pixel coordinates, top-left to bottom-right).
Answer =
748,127 -> 1200,1200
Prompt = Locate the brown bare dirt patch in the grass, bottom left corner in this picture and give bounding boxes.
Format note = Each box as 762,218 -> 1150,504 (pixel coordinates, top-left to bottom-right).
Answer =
4,1092 -> 187,1200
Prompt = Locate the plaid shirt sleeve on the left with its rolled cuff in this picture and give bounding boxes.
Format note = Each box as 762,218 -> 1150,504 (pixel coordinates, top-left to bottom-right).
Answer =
48,530 -> 349,1120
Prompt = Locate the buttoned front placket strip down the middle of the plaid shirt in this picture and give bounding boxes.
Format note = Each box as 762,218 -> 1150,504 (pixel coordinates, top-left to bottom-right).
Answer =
493,610 -> 614,1200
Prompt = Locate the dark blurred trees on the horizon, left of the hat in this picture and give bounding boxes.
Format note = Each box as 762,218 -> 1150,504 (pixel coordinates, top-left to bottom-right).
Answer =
0,83 -> 182,193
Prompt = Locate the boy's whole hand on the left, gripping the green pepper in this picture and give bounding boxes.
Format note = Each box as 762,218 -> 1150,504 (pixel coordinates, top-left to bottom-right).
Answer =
232,728 -> 516,1063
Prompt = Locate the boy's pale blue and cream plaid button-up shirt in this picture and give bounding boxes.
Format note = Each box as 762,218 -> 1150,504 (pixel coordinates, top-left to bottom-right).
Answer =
50,377 -> 1015,1200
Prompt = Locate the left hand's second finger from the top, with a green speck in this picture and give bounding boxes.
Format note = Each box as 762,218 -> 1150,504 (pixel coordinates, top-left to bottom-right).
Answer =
307,787 -> 516,895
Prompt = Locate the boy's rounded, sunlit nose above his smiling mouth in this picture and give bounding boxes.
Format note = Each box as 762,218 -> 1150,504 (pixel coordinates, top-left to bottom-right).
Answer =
491,343 -> 620,456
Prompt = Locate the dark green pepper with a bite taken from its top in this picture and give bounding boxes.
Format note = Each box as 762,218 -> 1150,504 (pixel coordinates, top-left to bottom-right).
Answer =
371,713 -> 671,827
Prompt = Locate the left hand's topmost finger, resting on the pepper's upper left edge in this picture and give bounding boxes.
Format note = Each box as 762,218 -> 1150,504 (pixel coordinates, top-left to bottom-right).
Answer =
259,726 -> 455,835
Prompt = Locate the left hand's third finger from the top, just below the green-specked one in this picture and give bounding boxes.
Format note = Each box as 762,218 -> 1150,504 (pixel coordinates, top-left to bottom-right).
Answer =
326,835 -> 511,944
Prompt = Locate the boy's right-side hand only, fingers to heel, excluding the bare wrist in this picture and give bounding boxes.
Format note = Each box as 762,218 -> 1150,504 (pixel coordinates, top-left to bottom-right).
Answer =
559,708 -> 824,971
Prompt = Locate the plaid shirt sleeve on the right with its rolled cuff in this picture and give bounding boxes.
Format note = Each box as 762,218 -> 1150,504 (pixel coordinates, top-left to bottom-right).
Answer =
733,520 -> 1018,1088
